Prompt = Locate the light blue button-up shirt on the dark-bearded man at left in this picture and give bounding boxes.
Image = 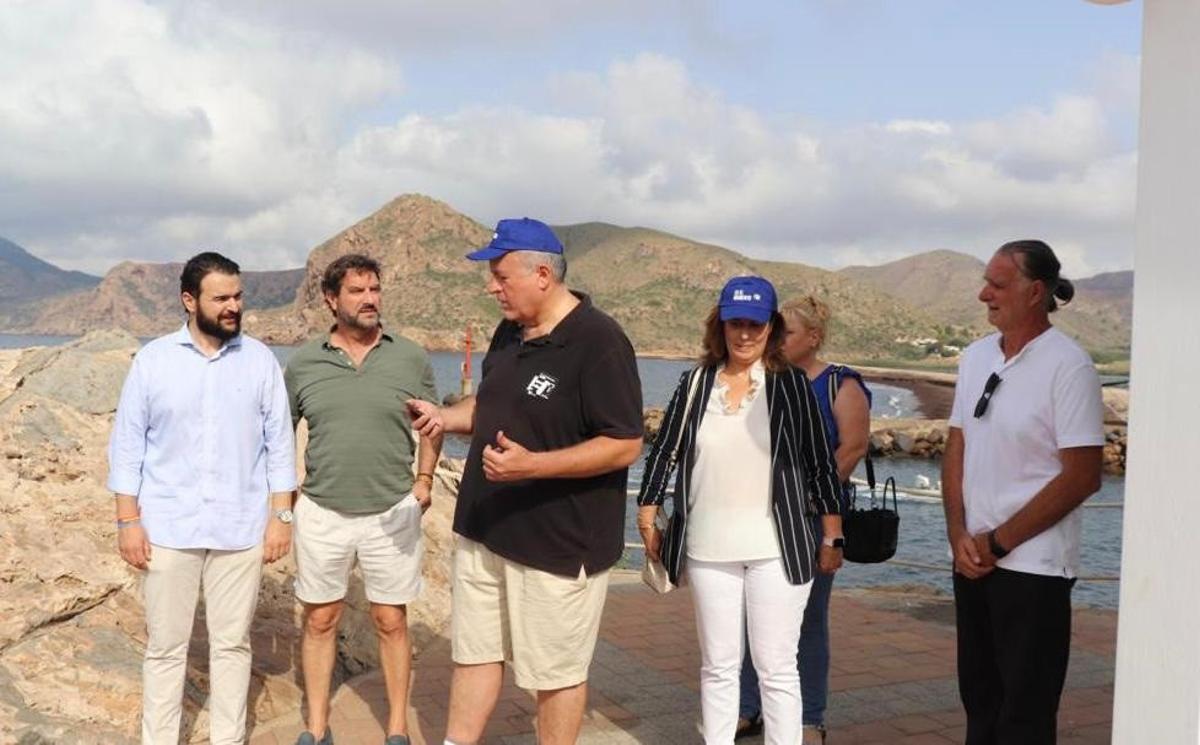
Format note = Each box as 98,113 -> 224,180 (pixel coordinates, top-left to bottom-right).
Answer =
108,324 -> 296,551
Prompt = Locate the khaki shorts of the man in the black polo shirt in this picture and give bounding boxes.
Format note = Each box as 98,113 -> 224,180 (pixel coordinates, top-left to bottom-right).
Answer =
450,536 -> 608,691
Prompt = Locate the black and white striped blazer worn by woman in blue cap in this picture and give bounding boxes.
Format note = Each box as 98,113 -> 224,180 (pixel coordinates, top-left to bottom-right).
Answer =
637,367 -> 840,584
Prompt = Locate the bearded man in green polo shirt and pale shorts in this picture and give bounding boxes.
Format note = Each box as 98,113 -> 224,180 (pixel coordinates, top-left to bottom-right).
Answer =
284,254 -> 442,745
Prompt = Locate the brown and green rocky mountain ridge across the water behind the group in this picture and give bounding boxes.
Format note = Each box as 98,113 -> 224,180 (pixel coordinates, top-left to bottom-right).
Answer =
0,194 -> 1132,359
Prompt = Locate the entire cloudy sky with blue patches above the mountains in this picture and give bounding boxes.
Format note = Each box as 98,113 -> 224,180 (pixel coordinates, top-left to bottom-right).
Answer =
0,0 -> 1141,276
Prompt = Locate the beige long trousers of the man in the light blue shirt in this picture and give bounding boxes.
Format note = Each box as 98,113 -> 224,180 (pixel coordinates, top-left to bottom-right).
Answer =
142,545 -> 263,745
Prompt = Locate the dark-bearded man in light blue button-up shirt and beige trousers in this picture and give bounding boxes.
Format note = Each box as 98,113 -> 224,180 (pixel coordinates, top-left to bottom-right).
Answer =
108,252 -> 296,745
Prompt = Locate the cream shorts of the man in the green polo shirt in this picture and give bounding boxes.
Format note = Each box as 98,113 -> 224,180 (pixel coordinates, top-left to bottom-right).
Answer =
293,493 -> 424,606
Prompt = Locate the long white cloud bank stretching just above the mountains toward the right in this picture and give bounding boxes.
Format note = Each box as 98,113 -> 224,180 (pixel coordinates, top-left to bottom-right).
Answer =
328,54 -> 1135,269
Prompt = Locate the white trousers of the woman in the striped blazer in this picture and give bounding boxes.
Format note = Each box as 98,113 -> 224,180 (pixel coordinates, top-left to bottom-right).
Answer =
688,557 -> 812,745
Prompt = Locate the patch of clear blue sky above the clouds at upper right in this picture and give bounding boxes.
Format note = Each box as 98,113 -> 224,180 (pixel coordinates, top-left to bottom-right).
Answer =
400,0 -> 1141,124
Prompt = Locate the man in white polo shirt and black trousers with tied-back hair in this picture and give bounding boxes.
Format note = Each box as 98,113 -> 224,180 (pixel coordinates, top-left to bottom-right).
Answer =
942,240 -> 1104,745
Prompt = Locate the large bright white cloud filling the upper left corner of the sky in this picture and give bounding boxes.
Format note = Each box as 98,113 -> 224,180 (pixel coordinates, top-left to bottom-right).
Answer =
0,0 -> 401,270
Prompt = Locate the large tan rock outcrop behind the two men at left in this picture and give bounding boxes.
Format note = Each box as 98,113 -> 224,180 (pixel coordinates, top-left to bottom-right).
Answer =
0,332 -> 461,745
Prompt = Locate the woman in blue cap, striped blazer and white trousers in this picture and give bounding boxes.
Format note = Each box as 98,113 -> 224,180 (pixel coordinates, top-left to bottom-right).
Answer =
637,277 -> 841,745
